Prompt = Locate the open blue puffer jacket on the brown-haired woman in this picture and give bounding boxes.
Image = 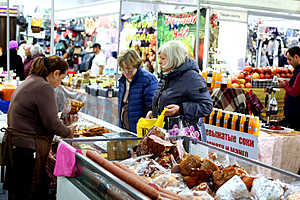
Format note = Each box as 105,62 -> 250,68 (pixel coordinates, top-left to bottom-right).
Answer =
118,68 -> 158,133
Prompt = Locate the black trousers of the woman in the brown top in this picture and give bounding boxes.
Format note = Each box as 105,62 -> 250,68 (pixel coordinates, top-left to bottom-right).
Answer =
5,148 -> 49,200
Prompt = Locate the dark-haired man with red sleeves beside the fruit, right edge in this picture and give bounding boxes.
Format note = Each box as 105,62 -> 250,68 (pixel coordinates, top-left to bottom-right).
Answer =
279,47 -> 300,131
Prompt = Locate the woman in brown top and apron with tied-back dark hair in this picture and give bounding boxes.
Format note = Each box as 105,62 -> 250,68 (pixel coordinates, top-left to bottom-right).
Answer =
4,56 -> 76,200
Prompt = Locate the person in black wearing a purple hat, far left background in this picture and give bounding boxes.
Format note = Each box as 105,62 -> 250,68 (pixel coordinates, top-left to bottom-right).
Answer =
2,40 -> 25,80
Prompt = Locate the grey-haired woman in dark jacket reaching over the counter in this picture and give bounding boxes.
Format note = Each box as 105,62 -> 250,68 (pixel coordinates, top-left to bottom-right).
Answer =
147,41 -> 213,141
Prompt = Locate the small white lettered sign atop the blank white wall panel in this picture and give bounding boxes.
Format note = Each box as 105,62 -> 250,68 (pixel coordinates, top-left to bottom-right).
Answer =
212,9 -> 248,23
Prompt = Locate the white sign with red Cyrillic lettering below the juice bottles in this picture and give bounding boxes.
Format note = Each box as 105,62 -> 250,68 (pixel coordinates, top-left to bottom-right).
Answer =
205,124 -> 258,160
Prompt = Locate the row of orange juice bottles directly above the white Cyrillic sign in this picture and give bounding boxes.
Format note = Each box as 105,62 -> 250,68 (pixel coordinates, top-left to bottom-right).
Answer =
203,108 -> 260,136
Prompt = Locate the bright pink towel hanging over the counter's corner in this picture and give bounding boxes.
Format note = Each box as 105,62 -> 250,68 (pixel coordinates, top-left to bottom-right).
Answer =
54,141 -> 82,177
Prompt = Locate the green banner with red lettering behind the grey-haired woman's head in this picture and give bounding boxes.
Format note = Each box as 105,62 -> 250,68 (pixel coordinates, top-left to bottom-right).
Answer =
157,11 -> 205,58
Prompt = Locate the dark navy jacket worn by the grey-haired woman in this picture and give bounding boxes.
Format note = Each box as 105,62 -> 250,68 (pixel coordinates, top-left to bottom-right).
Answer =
152,58 -> 213,141
